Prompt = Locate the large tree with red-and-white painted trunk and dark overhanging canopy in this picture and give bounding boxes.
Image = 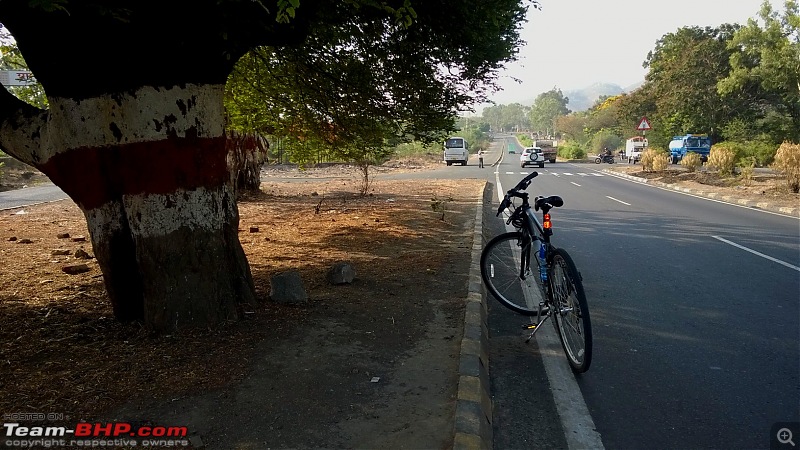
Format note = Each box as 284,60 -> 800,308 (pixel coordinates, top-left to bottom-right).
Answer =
0,0 -> 535,330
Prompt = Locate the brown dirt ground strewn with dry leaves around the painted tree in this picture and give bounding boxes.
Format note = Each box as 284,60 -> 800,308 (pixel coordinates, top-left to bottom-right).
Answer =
0,165 -> 483,449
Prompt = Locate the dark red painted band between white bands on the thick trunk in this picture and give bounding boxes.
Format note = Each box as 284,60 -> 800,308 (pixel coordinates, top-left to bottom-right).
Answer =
39,135 -> 230,209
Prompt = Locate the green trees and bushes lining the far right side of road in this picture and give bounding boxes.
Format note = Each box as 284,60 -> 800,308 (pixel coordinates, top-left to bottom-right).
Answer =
483,0 -> 800,179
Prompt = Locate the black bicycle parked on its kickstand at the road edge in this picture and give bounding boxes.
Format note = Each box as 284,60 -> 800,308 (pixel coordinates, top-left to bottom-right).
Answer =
481,172 -> 592,373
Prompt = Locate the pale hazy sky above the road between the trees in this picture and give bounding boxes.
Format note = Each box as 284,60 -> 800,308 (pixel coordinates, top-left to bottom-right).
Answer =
490,0 -> 783,104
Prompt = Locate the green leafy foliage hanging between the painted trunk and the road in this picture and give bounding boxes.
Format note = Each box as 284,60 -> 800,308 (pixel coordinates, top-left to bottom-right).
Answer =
226,0 -> 535,160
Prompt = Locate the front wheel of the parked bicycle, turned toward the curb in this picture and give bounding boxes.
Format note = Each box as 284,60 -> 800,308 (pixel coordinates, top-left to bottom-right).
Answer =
481,231 -> 539,316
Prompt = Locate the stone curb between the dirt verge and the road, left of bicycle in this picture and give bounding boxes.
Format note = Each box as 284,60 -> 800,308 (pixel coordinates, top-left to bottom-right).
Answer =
453,185 -> 492,450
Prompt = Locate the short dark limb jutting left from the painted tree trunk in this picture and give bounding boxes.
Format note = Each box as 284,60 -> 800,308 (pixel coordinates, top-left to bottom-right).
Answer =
0,87 -> 47,166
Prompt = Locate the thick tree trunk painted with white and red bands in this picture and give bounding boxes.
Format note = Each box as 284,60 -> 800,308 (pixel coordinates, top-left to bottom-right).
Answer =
34,85 -> 255,331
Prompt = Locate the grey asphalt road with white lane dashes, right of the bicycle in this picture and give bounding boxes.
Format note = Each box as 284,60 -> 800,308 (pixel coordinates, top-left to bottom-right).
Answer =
489,137 -> 800,449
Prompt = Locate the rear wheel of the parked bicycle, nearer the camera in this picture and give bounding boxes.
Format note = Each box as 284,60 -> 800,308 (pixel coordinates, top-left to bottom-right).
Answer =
549,248 -> 592,373
